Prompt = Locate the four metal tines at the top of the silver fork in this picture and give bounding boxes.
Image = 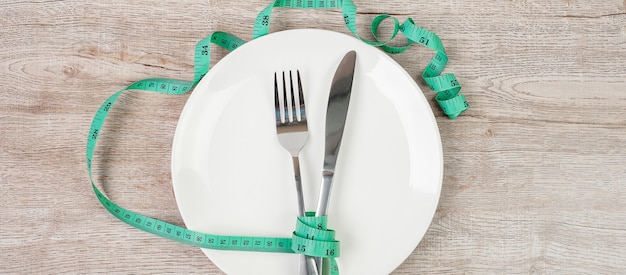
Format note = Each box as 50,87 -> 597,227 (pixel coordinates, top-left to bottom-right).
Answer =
274,70 -> 305,123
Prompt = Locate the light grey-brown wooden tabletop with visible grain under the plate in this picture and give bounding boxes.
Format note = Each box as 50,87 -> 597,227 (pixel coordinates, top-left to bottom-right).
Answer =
0,0 -> 626,274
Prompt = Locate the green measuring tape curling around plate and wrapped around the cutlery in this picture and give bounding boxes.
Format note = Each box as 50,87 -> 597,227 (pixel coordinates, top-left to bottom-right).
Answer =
86,0 -> 469,275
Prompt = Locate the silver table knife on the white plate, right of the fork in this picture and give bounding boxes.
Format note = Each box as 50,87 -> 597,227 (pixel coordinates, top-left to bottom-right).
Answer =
315,51 -> 356,274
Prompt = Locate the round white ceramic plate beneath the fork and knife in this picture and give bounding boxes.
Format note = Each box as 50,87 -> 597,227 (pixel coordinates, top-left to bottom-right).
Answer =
172,30 -> 443,275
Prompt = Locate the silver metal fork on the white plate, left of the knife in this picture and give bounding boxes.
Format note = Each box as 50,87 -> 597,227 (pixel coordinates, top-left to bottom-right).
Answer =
274,70 -> 318,275
